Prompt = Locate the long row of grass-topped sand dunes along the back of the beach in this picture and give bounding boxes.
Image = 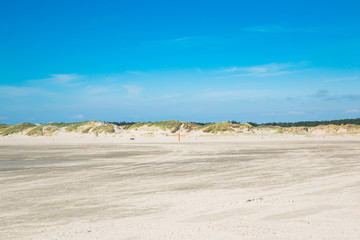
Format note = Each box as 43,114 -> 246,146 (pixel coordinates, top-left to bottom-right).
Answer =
0,120 -> 360,137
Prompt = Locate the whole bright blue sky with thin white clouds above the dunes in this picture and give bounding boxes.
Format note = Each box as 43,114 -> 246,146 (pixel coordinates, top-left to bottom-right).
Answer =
0,0 -> 360,124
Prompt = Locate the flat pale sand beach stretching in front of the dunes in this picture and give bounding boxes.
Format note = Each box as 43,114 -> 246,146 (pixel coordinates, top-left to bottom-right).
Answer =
0,138 -> 360,240
